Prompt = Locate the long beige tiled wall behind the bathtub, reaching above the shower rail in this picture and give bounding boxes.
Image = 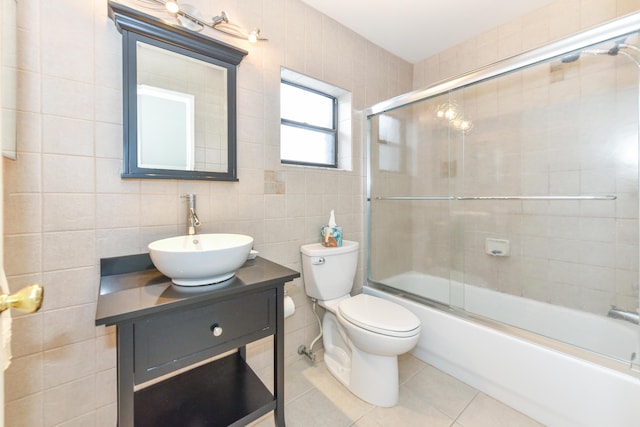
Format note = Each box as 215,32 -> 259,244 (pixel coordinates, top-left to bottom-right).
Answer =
412,1 -> 640,315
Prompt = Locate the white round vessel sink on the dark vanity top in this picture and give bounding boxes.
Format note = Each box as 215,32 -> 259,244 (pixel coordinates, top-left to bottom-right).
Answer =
148,233 -> 253,286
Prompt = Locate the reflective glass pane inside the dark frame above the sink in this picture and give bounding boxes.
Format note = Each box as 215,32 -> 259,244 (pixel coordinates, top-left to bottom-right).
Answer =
137,42 -> 228,172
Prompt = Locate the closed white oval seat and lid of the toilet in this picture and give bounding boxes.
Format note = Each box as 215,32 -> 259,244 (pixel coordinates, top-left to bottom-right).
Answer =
338,294 -> 420,337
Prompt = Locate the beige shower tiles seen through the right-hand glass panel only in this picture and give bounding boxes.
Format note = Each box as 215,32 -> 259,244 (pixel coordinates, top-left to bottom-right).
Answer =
452,49 -> 639,315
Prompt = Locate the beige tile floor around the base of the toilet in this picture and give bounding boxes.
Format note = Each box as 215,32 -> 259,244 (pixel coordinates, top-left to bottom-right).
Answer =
251,354 -> 541,427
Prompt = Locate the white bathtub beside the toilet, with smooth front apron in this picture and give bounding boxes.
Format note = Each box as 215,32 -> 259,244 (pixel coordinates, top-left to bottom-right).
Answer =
364,272 -> 640,427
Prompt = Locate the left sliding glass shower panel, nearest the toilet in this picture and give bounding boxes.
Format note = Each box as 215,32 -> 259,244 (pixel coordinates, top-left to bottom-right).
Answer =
369,94 -> 462,304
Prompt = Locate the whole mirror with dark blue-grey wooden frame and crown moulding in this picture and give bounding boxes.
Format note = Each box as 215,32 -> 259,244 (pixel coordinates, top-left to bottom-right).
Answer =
109,2 -> 247,181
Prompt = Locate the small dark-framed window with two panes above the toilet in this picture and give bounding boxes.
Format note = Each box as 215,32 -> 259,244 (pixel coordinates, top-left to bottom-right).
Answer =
280,80 -> 338,168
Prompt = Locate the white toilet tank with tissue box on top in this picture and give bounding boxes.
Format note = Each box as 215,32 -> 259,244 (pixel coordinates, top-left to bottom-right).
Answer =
300,240 -> 359,301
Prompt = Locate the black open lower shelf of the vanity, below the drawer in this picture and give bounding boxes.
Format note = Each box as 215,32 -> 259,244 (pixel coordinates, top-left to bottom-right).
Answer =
134,352 -> 276,427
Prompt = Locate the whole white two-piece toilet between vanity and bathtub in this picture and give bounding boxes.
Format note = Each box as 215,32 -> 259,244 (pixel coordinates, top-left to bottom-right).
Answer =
300,240 -> 421,407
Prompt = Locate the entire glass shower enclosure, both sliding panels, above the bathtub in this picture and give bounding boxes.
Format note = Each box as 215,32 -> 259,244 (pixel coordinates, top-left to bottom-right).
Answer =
368,30 -> 640,363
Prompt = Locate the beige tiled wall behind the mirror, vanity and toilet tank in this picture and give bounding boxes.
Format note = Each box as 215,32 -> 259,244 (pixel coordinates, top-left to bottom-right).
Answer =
4,0 -> 412,426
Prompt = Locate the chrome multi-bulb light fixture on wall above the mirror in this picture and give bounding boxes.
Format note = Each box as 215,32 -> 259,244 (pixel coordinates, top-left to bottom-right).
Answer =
136,0 -> 267,43
